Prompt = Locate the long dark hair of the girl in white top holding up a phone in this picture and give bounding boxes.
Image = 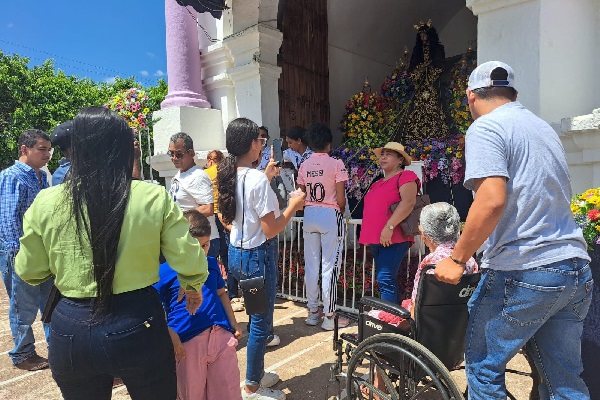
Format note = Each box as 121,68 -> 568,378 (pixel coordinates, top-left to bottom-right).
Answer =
217,118 -> 258,224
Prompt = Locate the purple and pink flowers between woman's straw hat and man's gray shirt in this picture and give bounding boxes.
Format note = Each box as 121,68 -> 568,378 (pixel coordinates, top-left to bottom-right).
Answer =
406,134 -> 465,185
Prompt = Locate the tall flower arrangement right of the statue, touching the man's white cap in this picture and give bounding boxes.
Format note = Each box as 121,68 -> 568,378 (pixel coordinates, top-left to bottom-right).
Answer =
448,52 -> 477,133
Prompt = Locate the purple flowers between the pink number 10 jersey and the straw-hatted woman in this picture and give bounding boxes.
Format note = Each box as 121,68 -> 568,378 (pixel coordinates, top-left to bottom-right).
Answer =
331,146 -> 379,200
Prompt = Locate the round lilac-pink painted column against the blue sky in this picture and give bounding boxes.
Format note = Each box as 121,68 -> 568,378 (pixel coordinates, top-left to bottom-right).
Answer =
160,0 -> 210,109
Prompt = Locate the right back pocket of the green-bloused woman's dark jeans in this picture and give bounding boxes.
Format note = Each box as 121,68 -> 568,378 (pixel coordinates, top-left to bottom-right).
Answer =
102,316 -> 162,370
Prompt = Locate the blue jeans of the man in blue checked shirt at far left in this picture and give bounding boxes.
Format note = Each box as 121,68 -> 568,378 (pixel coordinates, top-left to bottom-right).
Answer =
0,243 -> 54,365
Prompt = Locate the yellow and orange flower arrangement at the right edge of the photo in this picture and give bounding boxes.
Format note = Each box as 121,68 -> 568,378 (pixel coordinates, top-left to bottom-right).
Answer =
571,187 -> 600,250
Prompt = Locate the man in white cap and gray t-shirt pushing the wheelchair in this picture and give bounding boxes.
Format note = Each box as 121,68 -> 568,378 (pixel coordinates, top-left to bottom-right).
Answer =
435,61 -> 593,399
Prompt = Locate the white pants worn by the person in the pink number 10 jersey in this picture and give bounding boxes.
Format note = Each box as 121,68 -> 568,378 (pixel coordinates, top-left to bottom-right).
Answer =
303,206 -> 345,313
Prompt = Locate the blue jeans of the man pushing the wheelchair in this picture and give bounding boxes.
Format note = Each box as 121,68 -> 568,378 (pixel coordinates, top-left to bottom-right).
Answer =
465,258 -> 594,400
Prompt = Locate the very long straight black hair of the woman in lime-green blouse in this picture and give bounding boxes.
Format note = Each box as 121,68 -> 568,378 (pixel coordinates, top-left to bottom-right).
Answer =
65,107 -> 133,312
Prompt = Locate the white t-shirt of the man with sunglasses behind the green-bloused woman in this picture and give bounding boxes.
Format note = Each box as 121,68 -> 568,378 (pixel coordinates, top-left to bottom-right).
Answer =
169,165 -> 219,239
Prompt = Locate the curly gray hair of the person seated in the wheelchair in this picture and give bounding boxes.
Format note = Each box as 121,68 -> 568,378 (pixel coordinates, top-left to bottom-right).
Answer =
420,202 -> 460,244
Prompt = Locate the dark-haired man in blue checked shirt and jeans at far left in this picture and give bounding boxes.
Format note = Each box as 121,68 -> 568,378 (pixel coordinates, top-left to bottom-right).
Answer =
0,129 -> 52,371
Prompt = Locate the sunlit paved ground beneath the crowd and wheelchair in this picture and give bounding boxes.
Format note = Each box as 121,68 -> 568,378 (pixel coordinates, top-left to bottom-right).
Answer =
0,290 -> 531,400
